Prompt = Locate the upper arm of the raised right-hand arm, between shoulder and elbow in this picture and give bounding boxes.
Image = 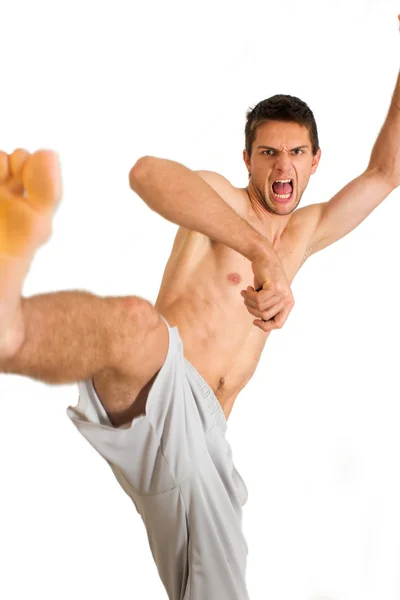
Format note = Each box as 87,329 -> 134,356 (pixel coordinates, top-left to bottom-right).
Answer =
309,171 -> 393,255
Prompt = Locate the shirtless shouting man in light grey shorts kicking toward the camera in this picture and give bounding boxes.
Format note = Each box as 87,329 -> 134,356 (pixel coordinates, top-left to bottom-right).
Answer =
0,54 -> 400,600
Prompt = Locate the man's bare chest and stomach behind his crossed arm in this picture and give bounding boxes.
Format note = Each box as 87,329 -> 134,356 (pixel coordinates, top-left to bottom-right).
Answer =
155,192 -> 310,417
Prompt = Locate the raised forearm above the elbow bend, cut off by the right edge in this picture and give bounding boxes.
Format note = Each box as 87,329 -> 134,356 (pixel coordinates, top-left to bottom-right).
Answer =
369,67 -> 400,180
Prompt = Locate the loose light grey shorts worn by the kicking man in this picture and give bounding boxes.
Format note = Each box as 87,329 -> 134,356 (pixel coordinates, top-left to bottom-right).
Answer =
67,322 -> 249,600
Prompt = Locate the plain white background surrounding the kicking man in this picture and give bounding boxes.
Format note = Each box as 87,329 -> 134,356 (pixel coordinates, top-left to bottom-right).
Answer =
0,0 -> 400,600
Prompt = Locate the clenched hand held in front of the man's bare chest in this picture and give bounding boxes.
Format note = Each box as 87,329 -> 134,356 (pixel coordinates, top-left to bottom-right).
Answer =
241,257 -> 294,333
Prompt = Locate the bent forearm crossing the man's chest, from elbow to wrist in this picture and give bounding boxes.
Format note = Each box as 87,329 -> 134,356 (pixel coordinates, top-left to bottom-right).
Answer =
129,157 -> 279,262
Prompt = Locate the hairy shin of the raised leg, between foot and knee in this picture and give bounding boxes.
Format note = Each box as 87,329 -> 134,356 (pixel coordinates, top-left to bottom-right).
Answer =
0,291 -> 135,384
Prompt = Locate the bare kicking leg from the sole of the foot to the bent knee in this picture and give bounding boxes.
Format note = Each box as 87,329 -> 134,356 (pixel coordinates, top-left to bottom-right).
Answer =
0,150 -> 168,420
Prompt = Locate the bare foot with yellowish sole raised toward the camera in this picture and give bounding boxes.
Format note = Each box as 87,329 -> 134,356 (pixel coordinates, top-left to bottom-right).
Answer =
0,149 -> 61,356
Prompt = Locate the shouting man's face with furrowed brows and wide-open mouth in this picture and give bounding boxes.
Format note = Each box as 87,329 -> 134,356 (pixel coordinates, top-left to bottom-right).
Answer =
243,121 -> 321,215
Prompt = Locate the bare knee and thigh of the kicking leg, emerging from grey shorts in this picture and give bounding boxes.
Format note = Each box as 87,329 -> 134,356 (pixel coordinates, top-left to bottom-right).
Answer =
93,298 -> 169,427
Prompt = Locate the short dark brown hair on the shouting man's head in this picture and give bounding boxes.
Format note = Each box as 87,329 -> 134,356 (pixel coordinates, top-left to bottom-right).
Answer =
245,94 -> 319,157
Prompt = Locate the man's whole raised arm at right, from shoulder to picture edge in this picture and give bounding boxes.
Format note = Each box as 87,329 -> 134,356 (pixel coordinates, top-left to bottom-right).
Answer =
299,57 -> 400,255
